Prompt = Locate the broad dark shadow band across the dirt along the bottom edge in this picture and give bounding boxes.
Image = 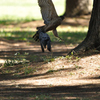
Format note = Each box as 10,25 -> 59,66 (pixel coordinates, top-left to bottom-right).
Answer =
0,84 -> 100,100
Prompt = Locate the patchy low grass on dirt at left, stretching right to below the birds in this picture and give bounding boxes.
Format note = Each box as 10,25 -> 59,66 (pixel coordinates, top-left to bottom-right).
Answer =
1,52 -> 54,77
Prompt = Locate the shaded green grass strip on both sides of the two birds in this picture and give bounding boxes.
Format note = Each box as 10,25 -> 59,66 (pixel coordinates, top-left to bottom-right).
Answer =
0,31 -> 86,44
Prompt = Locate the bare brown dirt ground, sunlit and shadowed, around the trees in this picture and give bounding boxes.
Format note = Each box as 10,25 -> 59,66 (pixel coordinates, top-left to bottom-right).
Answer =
0,16 -> 100,100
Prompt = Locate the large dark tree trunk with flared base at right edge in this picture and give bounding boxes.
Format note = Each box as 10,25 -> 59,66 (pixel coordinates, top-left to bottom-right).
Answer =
69,0 -> 100,54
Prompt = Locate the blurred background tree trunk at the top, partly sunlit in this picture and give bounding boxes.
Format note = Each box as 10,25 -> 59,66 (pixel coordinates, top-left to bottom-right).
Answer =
64,0 -> 93,17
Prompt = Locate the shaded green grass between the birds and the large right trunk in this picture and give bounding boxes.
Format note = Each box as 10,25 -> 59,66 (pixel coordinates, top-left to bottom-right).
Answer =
50,32 -> 87,44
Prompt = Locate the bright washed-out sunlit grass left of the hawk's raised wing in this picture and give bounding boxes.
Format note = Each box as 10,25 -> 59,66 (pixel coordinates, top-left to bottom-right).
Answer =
0,0 -> 41,20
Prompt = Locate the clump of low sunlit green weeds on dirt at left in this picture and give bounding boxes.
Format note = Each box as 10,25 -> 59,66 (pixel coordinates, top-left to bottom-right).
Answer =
2,52 -> 37,77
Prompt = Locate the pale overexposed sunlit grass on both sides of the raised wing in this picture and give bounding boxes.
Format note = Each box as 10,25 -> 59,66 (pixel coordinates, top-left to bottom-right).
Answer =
0,0 -> 65,21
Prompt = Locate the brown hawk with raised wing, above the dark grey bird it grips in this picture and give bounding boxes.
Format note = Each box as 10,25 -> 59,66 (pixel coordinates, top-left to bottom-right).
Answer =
38,0 -> 62,38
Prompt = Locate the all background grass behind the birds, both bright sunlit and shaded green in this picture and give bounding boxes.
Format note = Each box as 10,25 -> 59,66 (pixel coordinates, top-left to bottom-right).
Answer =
0,0 -> 87,44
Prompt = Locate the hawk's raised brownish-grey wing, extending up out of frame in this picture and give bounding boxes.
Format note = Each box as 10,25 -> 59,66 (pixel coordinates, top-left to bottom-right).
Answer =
38,0 -> 58,25
